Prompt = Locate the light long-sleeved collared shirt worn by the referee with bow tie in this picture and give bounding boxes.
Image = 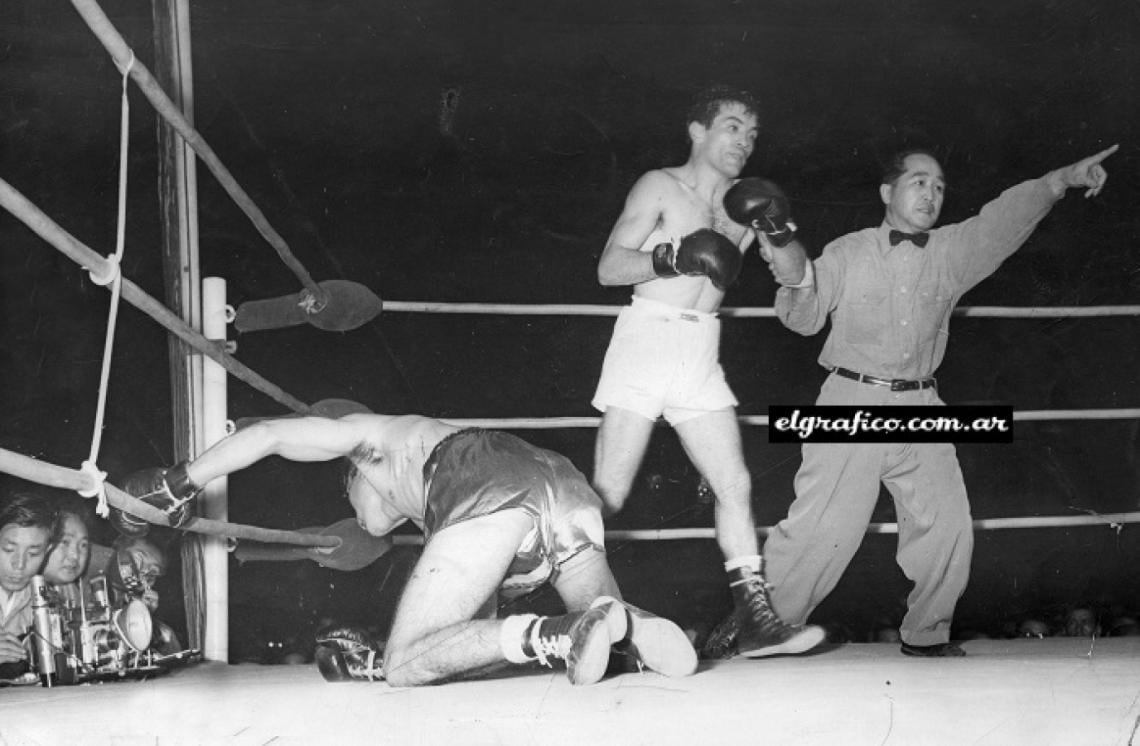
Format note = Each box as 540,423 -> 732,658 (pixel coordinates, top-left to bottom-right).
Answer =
775,178 -> 1058,380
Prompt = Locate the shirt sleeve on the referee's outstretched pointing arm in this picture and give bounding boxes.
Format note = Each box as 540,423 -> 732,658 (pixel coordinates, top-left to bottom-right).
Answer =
937,177 -> 1058,294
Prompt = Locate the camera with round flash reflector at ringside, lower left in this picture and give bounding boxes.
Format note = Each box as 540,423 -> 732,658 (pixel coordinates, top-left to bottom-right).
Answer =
30,575 -> 175,687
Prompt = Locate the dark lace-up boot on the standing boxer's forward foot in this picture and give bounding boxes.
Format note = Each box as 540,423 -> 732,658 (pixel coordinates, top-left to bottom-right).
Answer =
728,567 -> 825,658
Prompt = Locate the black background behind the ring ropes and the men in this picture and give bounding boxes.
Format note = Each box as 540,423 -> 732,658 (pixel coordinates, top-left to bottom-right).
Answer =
0,0 -> 1140,658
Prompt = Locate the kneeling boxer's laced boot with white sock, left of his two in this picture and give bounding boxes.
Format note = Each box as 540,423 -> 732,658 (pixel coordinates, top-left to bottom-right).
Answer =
507,595 -> 628,686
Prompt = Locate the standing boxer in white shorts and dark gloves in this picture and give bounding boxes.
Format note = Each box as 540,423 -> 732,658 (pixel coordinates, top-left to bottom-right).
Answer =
593,88 -> 824,657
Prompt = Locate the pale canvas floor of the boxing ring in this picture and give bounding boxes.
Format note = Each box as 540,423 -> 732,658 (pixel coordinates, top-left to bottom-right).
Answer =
0,638 -> 1140,746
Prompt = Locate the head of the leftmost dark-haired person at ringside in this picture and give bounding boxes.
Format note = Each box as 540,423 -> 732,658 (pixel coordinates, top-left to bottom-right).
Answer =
0,492 -> 58,593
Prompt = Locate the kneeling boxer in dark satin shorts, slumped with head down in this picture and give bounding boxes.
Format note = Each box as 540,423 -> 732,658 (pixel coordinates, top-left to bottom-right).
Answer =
122,414 -> 697,687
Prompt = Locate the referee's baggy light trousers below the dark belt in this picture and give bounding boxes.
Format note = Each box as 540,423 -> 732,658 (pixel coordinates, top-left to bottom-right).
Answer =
764,374 -> 974,646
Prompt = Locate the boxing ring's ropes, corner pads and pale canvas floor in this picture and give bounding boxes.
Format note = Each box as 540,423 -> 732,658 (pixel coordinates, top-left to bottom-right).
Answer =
0,0 -> 1140,745
